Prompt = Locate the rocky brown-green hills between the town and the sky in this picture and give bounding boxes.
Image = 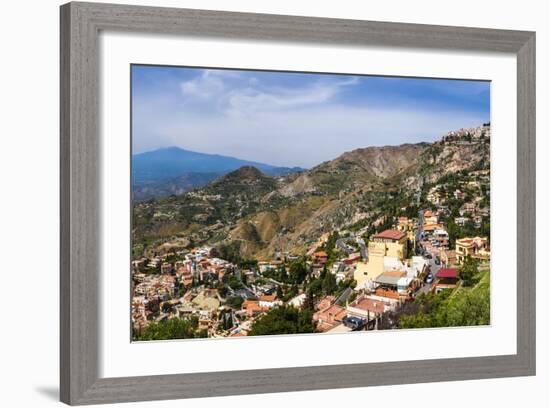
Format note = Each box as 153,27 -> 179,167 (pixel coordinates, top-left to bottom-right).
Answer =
133,126 -> 490,259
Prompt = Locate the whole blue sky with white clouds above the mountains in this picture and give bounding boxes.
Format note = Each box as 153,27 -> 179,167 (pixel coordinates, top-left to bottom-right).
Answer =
132,65 -> 490,168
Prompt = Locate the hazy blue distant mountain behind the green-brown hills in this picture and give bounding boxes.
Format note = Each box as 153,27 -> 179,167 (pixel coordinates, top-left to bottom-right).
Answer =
132,147 -> 304,200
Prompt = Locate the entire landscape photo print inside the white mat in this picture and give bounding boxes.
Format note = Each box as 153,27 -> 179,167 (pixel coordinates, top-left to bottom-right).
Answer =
129,64 -> 491,341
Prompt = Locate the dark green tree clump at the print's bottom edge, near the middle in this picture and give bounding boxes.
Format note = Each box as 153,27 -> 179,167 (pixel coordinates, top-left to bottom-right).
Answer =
248,306 -> 315,336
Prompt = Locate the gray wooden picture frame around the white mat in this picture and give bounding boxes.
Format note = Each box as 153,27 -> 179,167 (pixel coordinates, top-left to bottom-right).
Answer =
60,3 -> 535,405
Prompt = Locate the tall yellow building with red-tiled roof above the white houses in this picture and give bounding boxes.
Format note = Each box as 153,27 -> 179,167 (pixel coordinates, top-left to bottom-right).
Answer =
354,229 -> 407,287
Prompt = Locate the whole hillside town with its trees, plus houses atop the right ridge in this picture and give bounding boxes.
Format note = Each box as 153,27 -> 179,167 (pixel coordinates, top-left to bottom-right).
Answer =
132,127 -> 491,340
